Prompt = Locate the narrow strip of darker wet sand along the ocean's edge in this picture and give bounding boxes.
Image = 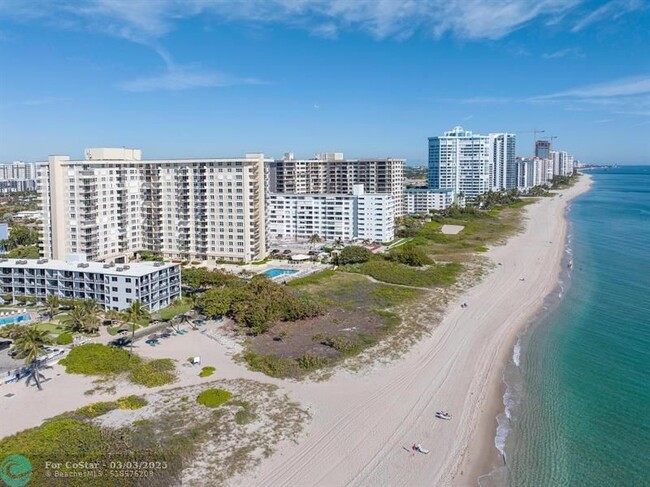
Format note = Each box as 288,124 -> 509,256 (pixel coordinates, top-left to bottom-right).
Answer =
465,173 -> 593,485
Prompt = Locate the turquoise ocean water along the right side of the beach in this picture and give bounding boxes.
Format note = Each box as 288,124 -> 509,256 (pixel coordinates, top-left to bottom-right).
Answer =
481,166 -> 650,487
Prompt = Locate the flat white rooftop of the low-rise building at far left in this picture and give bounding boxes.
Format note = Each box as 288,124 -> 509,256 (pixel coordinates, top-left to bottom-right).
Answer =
0,259 -> 178,277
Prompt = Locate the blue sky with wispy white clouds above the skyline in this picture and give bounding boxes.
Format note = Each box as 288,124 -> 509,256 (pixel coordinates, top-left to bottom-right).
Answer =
0,0 -> 650,164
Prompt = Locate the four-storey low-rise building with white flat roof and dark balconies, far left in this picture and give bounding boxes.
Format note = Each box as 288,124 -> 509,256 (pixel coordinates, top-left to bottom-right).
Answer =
0,259 -> 181,311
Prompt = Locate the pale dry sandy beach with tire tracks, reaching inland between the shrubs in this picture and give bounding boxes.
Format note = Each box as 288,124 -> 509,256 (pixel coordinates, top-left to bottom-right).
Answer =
0,176 -> 590,487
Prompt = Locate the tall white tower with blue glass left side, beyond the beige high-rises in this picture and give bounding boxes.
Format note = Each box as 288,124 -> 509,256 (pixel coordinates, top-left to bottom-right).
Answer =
429,127 -> 492,199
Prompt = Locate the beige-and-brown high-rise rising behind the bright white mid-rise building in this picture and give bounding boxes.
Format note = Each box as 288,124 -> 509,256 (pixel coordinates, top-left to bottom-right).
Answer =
267,152 -> 405,216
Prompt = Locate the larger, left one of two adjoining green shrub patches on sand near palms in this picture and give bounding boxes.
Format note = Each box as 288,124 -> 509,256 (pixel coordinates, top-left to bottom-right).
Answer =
59,343 -> 136,375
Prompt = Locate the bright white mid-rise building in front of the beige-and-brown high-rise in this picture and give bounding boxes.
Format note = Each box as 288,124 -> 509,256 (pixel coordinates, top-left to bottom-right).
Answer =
267,184 -> 395,242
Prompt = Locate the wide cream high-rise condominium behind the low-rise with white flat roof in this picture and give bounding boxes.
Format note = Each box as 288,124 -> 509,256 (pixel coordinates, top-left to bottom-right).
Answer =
39,148 -> 270,262
